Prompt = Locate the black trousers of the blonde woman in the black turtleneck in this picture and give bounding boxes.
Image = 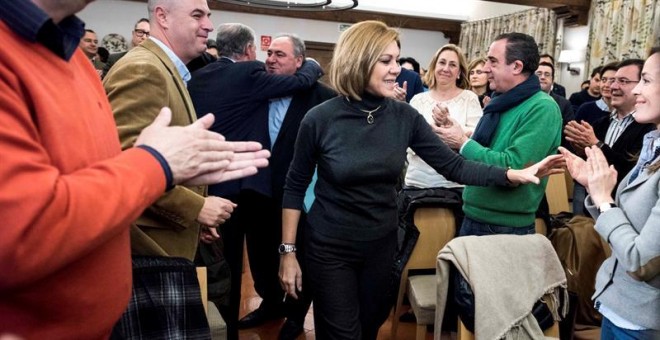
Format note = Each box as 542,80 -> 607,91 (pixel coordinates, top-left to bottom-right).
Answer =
303,228 -> 397,340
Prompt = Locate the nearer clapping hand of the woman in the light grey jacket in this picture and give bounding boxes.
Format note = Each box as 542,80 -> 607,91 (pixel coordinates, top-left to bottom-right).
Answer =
585,146 -> 617,206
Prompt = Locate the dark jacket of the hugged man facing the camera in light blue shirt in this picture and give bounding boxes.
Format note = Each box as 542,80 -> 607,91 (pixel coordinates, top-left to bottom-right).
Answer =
270,83 -> 337,202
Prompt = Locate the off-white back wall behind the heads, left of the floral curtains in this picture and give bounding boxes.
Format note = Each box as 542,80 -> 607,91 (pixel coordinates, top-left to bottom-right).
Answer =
78,0 -> 449,68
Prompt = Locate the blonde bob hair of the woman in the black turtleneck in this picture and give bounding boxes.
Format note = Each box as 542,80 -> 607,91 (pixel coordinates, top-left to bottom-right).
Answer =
329,20 -> 401,100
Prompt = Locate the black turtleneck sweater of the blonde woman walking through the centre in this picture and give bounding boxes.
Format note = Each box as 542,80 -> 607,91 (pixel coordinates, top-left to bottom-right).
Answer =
283,95 -> 506,241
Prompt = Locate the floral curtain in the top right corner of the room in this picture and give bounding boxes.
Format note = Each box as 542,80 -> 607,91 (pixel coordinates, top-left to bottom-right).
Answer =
586,0 -> 660,70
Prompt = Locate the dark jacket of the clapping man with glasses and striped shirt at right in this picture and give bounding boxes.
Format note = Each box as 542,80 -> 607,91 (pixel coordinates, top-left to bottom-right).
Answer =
593,116 -> 655,183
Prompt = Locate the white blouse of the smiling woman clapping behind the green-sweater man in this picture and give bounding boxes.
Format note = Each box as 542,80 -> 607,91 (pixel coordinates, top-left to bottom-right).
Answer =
405,90 -> 483,188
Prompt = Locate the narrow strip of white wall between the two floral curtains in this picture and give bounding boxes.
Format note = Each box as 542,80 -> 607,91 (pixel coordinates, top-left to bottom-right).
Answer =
557,26 -> 591,98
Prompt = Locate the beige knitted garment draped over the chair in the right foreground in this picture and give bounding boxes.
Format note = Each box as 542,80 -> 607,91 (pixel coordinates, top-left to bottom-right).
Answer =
434,234 -> 568,340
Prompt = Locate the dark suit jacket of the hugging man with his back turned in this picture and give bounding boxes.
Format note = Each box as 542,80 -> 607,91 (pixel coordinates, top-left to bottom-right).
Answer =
188,58 -> 323,197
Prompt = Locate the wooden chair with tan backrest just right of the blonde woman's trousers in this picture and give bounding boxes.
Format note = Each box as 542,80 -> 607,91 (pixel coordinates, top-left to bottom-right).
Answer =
392,207 -> 456,339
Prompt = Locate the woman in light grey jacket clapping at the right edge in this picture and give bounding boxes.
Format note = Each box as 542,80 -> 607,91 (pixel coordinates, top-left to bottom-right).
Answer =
560,47 -> 660,340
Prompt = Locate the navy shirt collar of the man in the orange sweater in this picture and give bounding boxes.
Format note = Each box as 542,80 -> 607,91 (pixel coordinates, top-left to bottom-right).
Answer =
0,0 -> 85,60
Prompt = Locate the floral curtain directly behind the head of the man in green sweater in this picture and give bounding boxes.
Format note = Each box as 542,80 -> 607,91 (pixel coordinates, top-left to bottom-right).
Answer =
459,8 -> 557,60
